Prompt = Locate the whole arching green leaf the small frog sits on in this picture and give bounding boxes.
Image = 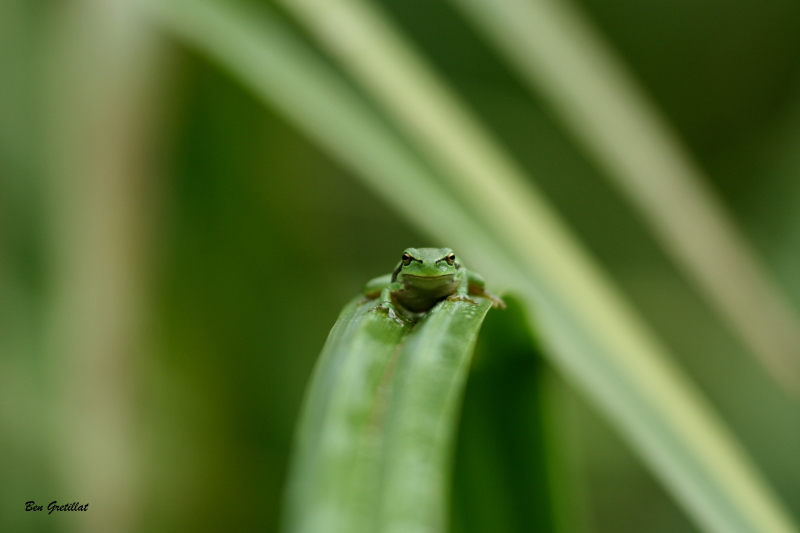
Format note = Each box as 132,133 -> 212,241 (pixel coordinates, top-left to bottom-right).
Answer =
284,301 -> 490,533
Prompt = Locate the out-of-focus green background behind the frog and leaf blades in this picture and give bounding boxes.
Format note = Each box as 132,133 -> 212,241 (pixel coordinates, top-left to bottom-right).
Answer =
0,0 -> 800,533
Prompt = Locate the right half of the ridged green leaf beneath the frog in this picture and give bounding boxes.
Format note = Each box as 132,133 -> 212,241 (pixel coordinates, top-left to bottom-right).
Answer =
379,300 -> 491,533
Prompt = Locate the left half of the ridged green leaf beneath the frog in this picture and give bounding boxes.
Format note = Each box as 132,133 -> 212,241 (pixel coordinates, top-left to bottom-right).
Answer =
284,301 -> 411,533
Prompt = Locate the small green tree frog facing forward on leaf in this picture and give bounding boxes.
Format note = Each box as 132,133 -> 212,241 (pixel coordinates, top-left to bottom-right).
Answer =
364,248 -> 505,321
